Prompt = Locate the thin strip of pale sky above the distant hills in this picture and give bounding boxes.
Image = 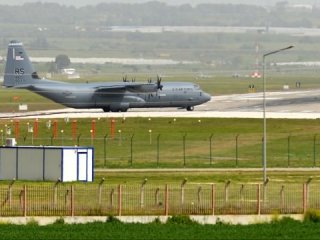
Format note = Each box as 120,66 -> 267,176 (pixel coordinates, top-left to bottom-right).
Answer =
0,0 -> 320,7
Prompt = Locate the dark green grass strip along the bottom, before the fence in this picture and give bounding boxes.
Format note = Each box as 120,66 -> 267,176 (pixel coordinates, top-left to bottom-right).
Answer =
0,218 -> 320,240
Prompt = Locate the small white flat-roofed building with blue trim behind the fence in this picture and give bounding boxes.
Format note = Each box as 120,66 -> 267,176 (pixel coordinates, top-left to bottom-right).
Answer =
0,146 -> 94,182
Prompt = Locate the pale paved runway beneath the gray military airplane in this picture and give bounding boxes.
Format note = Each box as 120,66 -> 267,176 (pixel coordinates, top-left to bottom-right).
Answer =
0,89 -> 320,119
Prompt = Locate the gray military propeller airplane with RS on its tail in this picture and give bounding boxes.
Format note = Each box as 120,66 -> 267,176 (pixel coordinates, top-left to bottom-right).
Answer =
3,41 -> 211,112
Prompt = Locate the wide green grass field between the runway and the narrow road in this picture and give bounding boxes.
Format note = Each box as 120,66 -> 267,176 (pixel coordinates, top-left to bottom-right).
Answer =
0,118 -> 320,168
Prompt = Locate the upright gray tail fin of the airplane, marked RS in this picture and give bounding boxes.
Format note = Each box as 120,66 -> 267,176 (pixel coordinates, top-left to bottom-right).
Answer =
3,41 -> 39,87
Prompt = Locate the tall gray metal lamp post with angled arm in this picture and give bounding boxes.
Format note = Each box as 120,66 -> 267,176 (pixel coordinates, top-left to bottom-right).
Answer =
262,46 -> 294,182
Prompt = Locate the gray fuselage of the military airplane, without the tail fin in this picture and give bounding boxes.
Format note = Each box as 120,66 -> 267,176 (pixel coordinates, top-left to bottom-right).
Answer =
27,80 -> 210,111
